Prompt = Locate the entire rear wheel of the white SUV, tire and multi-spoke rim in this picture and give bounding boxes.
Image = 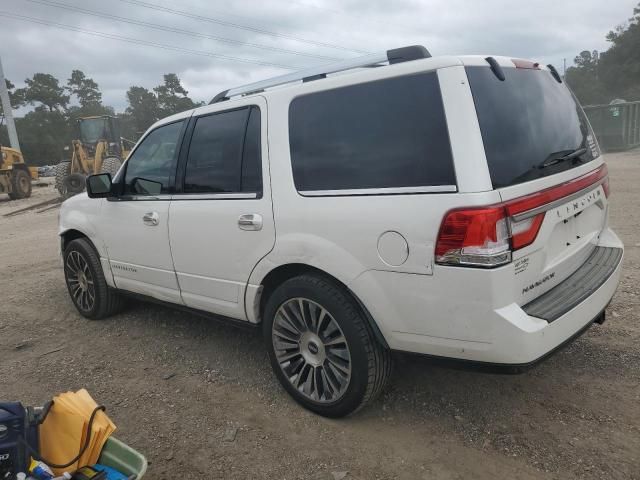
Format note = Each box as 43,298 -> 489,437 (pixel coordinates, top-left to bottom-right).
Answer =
263,275 -> 391,417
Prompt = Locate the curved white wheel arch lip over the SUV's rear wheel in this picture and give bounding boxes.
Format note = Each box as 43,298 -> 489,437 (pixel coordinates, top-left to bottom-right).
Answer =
250,263 -> 389,349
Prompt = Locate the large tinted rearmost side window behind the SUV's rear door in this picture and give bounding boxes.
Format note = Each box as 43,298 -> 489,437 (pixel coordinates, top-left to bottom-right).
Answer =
289,72 -> 456,192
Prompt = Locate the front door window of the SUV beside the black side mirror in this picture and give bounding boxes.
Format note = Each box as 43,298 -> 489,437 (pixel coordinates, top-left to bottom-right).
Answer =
124,121 -> 184,195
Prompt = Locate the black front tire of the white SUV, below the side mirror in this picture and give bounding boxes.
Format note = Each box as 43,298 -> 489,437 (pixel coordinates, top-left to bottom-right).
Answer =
63,238 -> 124,320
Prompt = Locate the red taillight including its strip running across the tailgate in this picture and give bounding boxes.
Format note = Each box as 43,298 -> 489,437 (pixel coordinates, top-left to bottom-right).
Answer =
435,165 -> 609,268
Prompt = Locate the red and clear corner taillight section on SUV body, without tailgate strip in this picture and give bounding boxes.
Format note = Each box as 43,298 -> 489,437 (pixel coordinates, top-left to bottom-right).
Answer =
435,205 -> 511,267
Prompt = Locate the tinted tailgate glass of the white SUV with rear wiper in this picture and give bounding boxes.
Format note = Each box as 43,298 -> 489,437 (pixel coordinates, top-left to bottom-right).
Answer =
466,67 -> 598,188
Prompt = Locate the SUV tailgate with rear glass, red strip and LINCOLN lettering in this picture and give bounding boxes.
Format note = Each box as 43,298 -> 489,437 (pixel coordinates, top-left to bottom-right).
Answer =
466,61 -> 608,305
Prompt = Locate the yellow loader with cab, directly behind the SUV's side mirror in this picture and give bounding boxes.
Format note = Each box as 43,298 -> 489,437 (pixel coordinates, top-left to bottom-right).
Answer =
56,115 -> 134,197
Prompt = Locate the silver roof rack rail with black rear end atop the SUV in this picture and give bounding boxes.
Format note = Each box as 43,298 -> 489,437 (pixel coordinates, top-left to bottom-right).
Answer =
209,45 -> 431,105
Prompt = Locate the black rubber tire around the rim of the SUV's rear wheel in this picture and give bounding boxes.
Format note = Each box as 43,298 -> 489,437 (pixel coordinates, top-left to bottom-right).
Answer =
263,274 -> 392,418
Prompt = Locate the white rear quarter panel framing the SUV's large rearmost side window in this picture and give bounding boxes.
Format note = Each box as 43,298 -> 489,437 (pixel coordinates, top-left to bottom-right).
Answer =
246,60 -> 500,336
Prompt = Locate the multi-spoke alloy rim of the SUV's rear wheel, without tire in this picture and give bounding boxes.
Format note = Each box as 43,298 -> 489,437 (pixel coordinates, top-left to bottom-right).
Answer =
271,298 -> 351,403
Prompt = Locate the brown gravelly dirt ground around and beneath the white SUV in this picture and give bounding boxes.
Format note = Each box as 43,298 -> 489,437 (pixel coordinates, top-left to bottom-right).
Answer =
0,155 -> 640,480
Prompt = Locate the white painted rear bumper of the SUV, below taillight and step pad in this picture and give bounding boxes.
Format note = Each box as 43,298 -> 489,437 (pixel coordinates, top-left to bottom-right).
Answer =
354,229 -> 623,367
